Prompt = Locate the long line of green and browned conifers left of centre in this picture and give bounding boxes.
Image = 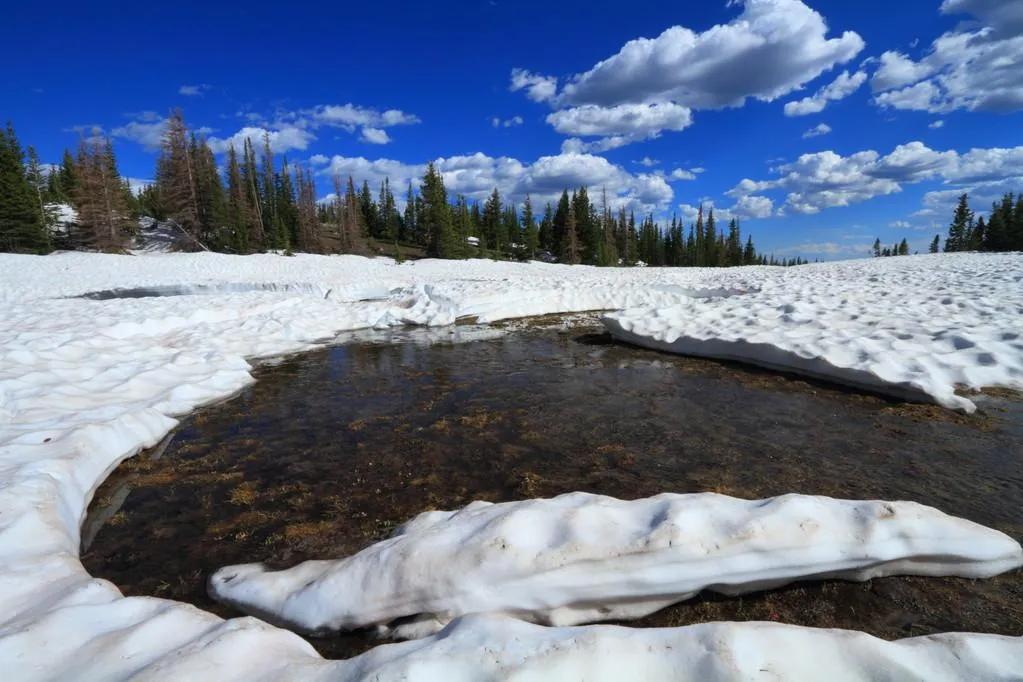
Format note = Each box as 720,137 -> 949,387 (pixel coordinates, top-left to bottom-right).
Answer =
0,110 -> 781,267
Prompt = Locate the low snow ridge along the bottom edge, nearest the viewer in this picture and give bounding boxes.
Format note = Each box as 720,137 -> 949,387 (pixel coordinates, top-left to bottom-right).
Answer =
321,616 -> 1023,682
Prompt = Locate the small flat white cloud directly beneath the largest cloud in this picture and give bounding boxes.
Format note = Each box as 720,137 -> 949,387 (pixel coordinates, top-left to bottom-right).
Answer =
547,102 -> 693,150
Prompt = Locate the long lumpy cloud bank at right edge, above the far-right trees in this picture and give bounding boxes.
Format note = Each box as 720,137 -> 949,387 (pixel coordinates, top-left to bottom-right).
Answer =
725,141 -> 1023,214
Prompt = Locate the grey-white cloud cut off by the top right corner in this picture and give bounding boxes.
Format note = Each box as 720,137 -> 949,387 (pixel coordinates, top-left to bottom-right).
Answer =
871,0 -> 1023,113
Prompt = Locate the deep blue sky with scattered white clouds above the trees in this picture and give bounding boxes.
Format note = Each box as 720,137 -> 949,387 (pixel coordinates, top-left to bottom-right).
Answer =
6,0 -> 1023,258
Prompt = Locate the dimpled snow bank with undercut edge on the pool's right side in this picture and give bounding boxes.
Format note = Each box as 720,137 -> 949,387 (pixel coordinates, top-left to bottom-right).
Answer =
605,255 -> 1023,412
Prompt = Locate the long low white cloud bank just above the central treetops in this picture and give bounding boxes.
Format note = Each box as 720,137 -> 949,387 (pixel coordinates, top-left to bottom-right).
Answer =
318,152 -> 674,213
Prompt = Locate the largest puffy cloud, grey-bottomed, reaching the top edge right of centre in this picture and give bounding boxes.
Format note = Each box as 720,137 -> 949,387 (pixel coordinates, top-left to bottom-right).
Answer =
559,0 -> 863,108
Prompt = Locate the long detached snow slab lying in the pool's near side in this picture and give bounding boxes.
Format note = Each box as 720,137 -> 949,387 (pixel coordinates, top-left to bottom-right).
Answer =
210,493 -> 1023,637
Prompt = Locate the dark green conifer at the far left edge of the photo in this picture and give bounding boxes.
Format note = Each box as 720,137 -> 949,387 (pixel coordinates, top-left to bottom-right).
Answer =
0,124 -> 49,254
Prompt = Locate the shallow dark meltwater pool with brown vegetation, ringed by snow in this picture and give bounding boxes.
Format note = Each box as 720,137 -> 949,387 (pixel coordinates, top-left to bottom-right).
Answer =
83,328 -> 1023,656
